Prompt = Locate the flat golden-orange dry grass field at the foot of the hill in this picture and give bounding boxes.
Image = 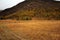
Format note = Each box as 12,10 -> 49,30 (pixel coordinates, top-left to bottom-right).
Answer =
0,20 -> 60,40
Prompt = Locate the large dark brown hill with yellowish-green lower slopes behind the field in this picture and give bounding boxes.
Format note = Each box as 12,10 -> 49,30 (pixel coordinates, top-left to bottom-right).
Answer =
0,0 -> 60,19
